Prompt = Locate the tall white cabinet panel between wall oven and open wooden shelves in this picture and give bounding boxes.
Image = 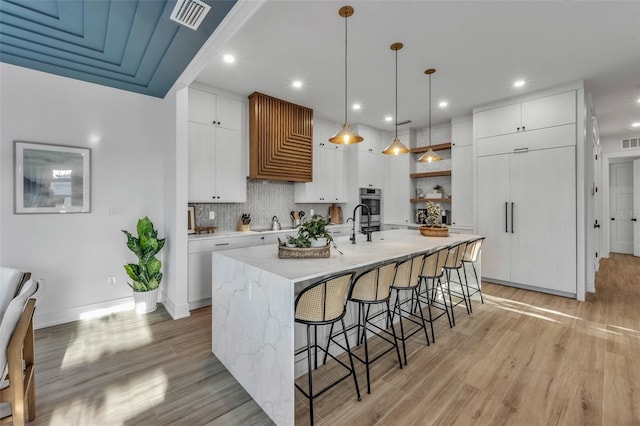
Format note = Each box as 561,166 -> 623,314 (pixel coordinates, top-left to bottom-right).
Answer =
382,155 -> 411,223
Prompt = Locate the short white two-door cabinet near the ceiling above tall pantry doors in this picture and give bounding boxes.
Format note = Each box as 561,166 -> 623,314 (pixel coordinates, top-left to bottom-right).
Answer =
474,91 -> 576,139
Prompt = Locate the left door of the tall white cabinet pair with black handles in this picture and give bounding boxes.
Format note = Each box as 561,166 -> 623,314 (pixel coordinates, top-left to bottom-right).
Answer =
478,154 -> 511,281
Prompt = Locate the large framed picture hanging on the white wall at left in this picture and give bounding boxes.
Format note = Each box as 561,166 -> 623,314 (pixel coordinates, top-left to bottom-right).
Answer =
13,141 -> 91,214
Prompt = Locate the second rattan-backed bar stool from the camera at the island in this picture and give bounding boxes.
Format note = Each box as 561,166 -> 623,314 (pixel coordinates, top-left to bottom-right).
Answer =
325,262 -> 402,393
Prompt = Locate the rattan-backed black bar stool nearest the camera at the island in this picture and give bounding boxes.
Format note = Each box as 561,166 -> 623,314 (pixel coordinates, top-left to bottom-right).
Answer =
295,272 -> 360,425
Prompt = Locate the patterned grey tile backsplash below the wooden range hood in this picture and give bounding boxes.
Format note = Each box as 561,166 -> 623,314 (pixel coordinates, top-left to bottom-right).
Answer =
189,179 -> 344,232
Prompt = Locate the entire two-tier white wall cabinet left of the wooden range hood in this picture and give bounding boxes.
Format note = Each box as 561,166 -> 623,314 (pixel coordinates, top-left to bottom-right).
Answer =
188,88 -> 247,203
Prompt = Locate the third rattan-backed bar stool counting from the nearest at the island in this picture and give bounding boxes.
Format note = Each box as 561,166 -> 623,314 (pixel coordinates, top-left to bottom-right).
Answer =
391,253 -> 431,365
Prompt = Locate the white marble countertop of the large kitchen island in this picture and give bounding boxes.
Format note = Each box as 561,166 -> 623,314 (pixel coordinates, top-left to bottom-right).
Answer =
214,229 -> 476,282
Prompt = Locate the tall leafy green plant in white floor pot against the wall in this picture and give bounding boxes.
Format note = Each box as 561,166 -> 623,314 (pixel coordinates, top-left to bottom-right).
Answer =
122,216 -> 166,291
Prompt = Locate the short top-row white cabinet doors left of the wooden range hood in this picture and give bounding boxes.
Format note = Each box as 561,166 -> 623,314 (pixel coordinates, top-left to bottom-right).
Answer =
189,87 -> 244,131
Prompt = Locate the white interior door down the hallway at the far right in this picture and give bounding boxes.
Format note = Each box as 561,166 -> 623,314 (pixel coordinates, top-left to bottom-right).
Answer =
609,162 -> 633,254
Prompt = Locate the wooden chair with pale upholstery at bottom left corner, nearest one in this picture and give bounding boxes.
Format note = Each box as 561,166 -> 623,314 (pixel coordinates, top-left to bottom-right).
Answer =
0,282 -> 38,426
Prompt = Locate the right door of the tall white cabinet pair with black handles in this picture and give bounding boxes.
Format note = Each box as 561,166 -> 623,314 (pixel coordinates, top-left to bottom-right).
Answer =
510,146 -> 576,294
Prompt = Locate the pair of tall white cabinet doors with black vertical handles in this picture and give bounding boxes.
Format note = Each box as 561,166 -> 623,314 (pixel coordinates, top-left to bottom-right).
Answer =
478,147 -> 576,295
